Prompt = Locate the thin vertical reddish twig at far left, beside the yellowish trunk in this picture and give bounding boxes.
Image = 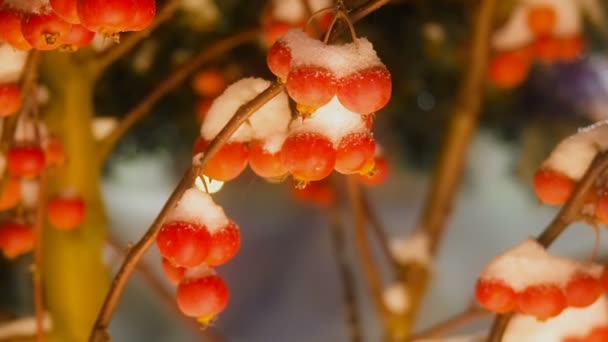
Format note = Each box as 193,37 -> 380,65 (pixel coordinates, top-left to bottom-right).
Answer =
32,169 -> 47,342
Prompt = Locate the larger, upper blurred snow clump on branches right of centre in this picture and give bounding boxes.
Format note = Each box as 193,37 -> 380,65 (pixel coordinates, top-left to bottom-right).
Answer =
389,231 -> 432,266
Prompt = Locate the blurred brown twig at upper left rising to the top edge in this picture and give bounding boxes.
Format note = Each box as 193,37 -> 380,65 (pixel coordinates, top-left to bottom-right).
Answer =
88,0 -> 181,77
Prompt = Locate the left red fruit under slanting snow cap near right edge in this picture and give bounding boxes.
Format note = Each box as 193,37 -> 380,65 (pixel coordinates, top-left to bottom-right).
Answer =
534,169 -> 576,205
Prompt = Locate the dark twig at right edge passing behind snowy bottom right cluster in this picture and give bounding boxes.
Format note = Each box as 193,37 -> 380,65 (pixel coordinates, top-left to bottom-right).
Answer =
487,151 -> 608,342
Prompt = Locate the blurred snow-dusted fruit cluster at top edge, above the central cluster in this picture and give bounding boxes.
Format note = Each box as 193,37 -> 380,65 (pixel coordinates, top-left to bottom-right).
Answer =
262,0 -> 333,47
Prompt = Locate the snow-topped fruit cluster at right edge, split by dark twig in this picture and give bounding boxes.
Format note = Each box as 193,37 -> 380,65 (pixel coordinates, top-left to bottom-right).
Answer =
534,123 -> 608,225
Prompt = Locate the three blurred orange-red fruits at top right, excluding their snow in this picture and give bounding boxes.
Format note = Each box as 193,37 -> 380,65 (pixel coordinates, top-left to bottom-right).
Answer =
489,5 -> 584,88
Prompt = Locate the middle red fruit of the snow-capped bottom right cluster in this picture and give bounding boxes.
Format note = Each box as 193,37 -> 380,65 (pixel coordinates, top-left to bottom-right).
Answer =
517,285 -> 568,320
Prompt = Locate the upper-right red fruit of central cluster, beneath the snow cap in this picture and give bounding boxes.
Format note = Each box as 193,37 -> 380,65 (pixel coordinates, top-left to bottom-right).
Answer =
337,66 -> 393,115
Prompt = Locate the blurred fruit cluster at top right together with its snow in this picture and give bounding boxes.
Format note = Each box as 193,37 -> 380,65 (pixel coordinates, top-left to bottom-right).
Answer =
489,0 -> 584,88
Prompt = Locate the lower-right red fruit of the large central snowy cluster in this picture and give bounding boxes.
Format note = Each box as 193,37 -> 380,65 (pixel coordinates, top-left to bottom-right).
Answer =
335,132 -> 376,175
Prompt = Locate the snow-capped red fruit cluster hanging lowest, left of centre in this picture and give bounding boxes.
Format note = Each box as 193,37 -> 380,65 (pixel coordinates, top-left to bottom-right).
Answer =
156,188 -> 241,324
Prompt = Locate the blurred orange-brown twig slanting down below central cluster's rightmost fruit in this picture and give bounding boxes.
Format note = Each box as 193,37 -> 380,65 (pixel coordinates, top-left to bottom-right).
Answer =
347,177 -> 388,319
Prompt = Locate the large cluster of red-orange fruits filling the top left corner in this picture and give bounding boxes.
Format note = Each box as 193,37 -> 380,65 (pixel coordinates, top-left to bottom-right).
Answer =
0,0 -> 156,51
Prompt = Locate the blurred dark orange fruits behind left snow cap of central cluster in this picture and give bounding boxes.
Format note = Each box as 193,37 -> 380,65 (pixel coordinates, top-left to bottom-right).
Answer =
192,69 -> 226,122
